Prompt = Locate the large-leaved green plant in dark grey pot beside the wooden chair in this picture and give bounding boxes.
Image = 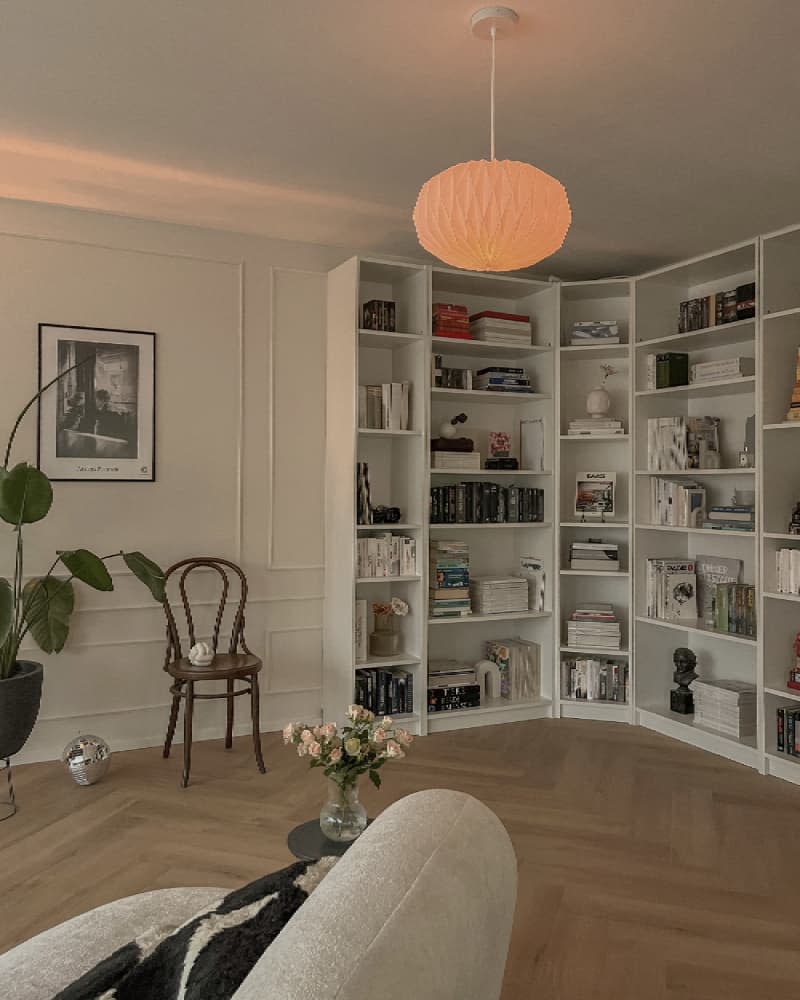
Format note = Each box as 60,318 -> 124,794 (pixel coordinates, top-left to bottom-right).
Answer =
0,365 -> 165,784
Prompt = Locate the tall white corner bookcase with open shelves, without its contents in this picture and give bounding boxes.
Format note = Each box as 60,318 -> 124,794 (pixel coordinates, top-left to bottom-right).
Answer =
323,227 -> 800,782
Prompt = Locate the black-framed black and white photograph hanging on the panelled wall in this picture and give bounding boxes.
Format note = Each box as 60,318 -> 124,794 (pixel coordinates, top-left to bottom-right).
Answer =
39,323 -> 156,482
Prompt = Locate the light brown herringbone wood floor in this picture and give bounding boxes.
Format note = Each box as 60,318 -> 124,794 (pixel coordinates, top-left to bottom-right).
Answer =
0,720 -> 800,1000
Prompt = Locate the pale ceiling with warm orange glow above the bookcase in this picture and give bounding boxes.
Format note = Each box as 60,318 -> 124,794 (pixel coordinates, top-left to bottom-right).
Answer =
0,0 -> 800,277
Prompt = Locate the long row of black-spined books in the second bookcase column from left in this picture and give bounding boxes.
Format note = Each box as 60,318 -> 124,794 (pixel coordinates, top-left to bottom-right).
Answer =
430,481 -> 544,524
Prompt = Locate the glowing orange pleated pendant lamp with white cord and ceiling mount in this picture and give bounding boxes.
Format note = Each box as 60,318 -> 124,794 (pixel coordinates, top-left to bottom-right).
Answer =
414,7 -> 572,271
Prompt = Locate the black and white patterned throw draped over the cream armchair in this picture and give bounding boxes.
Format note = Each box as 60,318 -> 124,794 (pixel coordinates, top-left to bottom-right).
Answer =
53,858 -> 338,1000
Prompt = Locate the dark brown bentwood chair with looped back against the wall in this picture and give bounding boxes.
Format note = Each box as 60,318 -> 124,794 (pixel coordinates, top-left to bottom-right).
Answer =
164,556 -> 266,788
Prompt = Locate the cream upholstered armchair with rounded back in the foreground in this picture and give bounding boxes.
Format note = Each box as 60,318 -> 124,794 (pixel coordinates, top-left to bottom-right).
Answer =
0,790 -> 517,1000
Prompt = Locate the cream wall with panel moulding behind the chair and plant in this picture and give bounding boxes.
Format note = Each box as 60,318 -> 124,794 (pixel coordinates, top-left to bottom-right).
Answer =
0,201 -> 348,762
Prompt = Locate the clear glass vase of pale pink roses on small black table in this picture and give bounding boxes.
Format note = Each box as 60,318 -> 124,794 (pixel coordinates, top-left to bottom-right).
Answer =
283,705 -> 413,842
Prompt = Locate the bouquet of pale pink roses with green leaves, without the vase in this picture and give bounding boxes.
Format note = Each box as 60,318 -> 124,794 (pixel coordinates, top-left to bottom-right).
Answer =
283,705 -> 414,788
